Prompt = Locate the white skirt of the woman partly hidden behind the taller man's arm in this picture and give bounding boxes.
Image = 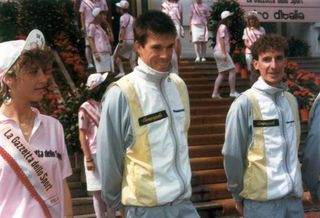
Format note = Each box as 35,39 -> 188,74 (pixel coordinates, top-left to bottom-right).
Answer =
84,154 -> 101,191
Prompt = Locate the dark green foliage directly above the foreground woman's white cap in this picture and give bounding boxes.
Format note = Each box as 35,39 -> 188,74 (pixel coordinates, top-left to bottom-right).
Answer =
18,0 -> 79,45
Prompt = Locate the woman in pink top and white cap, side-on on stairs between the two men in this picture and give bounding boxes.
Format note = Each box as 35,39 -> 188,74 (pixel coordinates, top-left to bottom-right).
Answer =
212,11 -> 239,98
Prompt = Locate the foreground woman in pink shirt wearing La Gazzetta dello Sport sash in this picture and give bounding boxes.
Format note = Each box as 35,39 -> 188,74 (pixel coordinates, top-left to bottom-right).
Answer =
0,30 -> 73,218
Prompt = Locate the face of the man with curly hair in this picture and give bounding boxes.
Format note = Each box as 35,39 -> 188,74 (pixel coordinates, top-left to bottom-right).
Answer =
253,50 -> 287,87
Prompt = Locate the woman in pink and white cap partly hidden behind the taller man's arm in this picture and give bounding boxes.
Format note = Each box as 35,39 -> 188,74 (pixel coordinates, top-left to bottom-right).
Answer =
78,73 -> 115,218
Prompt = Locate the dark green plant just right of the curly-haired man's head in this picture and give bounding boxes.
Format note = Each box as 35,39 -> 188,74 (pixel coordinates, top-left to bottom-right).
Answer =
287,37 -> 310,57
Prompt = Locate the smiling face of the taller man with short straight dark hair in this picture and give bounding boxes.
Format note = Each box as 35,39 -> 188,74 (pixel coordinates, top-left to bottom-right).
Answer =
135,32 -> 175,72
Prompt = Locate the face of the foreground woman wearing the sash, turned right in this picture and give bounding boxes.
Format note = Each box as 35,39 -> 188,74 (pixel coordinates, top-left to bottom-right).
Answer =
9,67 -> 51,102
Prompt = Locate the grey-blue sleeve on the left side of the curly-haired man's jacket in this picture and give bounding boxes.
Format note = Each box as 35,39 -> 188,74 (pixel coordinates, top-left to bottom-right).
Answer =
222,95 -> 252,201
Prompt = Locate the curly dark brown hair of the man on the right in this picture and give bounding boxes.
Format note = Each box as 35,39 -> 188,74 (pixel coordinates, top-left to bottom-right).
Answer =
251,34 -> 288,60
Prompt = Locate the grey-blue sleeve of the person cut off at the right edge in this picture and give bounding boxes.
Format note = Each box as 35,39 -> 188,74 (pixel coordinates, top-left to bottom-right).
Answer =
302,97 -> 320,199
